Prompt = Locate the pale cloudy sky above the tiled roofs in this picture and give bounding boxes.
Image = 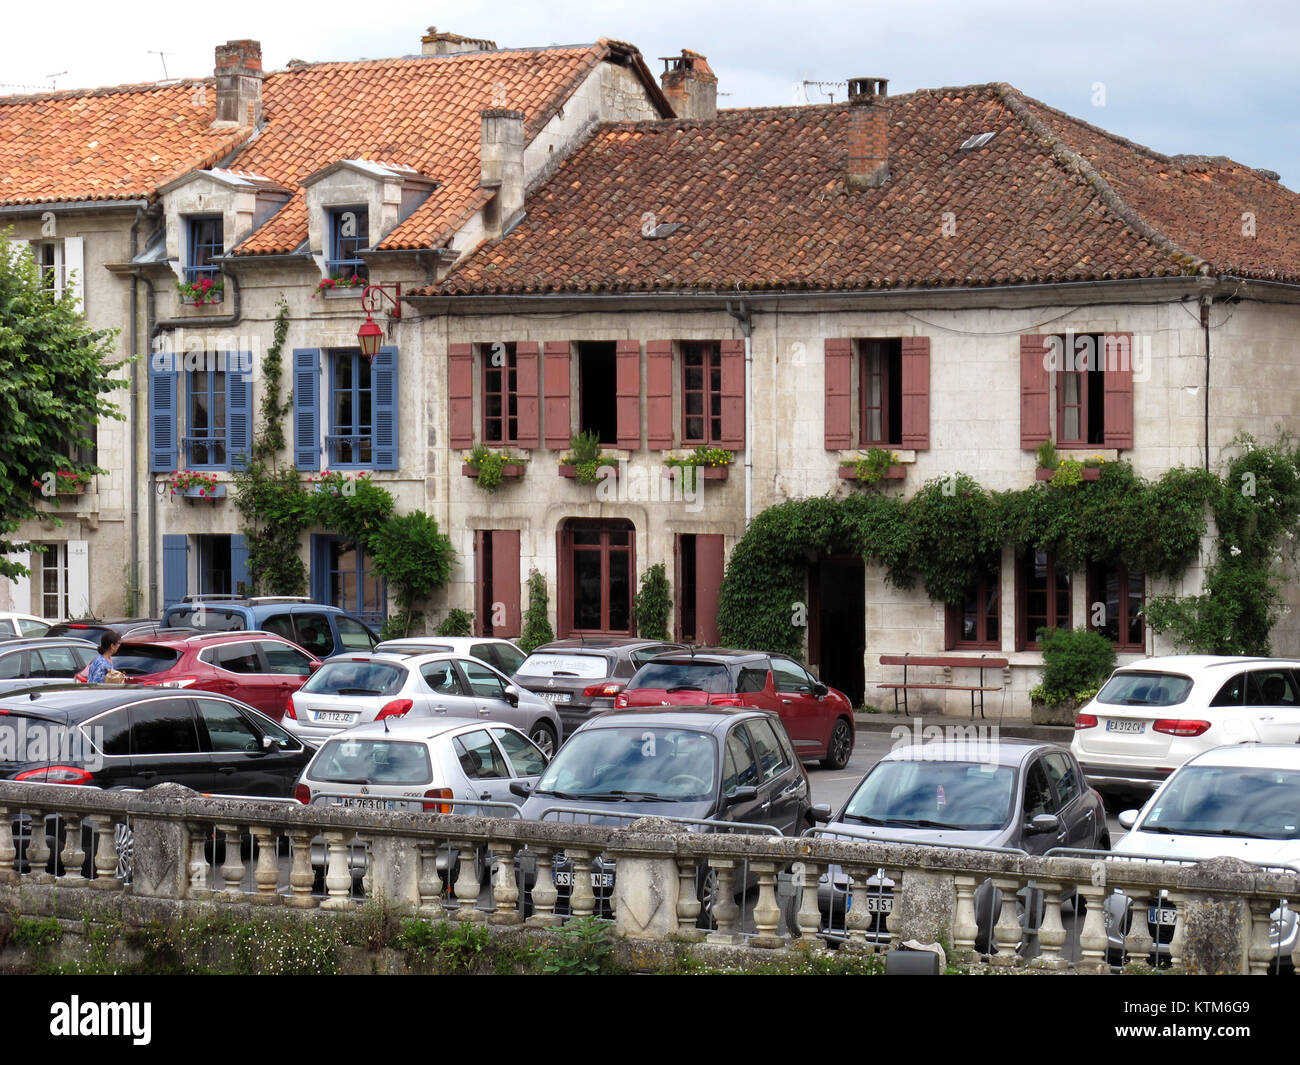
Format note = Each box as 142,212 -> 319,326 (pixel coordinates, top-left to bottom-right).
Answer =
10,0 -> 1300,190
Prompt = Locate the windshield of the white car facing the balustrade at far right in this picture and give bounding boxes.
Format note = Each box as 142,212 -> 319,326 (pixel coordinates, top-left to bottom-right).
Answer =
1138,766 -> 1300,840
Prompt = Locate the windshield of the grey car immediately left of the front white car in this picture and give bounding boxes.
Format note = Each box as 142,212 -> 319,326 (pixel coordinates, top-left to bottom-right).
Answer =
844,758 -> 1015,831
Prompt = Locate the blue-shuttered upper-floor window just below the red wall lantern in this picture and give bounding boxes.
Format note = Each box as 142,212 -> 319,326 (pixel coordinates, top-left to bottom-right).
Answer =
294,347 -> 398,469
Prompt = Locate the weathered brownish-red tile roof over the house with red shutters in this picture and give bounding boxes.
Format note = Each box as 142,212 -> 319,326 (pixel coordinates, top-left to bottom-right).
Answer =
425,85 -> 1300,295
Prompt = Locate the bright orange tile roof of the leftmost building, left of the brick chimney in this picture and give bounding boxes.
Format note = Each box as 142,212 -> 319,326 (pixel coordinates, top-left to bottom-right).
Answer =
0,79 -> 251,204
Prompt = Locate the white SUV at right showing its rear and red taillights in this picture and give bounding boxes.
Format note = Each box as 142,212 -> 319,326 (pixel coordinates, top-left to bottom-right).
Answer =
1070,655 -> 1300,793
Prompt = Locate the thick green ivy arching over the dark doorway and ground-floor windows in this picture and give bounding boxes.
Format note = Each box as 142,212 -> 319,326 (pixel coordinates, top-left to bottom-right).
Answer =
718,463 -> 1221,663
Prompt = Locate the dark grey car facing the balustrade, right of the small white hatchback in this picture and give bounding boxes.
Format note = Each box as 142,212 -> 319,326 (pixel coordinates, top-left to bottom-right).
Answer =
512,706 -> 829,921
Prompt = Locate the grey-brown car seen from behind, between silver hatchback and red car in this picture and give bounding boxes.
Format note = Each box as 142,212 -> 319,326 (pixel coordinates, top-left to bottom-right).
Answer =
514,636 -> 685,739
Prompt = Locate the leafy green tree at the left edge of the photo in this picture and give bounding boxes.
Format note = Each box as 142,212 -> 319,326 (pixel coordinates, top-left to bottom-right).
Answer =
0,230 -> 126,579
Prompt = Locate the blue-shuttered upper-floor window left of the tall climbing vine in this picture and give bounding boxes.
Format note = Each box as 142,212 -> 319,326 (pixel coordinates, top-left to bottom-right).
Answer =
150,351 -> 252,473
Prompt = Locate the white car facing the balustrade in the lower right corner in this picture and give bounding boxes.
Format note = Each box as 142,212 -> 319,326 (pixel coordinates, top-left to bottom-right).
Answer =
1105,744 -> 1300,969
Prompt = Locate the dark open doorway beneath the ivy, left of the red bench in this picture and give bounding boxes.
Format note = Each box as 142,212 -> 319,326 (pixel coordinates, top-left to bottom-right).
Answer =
809,558 -> 867,706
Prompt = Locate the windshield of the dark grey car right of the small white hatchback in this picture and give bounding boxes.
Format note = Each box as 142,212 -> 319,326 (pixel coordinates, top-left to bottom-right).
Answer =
537,726 -> 718,802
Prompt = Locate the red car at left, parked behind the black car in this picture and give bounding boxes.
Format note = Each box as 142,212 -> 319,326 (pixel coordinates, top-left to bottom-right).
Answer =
77,631 -> 321,722
